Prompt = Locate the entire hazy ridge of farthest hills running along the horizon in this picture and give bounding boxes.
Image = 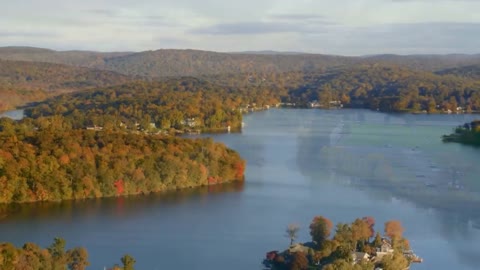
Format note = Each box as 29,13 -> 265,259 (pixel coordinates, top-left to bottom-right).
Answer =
0,47 -> 480,78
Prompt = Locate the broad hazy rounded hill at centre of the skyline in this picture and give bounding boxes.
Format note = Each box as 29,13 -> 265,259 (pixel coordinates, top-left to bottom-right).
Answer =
100,50 -> 360,77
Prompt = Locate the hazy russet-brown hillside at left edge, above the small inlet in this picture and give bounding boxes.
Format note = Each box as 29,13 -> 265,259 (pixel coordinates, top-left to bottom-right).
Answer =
0,60 -> 135,111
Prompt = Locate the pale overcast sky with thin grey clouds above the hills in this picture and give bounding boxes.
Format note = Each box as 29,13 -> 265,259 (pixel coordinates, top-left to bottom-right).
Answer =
0,0 -> 480,55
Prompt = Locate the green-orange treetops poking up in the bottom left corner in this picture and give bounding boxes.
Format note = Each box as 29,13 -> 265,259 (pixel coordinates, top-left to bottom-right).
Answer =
0,238 -> 135,270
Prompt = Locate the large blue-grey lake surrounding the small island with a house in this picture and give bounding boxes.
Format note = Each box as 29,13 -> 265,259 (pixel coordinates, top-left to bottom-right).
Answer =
0,109 -> 480,270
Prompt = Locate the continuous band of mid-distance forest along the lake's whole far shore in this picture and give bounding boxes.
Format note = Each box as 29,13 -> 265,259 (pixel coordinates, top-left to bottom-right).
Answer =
18,65 -> 480,131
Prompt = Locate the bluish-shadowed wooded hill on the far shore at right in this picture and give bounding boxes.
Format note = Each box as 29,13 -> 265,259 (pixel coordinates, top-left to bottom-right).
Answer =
290,65 -> 480,113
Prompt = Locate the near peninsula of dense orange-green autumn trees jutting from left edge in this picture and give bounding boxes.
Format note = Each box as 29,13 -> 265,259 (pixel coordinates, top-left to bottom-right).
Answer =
0,115 -> 245,203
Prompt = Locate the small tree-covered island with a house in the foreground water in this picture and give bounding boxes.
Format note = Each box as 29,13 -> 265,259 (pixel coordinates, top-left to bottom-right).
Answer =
263,216 -> 422,270
